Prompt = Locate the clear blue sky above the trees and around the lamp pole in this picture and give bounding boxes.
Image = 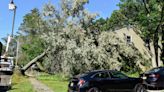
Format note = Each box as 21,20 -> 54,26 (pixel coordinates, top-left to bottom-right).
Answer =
0,0 -> 119,40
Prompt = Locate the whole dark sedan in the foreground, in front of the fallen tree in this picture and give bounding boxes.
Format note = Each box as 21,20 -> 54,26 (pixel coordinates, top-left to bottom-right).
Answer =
68,70 -> 145,92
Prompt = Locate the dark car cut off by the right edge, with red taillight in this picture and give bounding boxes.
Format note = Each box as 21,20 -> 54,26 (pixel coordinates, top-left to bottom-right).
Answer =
140,67 -> 164,89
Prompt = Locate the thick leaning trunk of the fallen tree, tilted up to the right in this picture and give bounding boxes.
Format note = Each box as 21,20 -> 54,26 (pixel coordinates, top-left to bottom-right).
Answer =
21,48 -> 49,75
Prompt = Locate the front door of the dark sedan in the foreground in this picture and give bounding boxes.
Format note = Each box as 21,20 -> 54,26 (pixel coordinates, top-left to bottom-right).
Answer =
110,71 -> 131,91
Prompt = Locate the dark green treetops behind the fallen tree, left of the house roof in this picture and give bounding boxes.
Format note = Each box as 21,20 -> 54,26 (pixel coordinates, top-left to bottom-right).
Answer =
90,10 -> 127,31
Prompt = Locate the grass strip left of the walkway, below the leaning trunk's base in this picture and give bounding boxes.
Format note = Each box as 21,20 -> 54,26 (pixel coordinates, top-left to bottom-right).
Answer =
9,73 -> 35,92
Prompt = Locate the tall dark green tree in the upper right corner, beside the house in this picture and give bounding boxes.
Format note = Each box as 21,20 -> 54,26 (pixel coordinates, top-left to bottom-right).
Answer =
119,0 -> 164,66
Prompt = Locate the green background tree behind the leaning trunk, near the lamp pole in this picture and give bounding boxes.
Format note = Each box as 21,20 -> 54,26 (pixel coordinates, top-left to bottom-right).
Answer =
17,8 -> 45,65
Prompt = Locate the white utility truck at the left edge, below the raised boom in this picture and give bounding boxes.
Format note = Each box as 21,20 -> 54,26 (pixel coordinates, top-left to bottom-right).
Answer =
0,57 -> 14,88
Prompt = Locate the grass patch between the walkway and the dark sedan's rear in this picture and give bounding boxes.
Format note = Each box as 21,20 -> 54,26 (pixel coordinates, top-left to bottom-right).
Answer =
37,74 -> 68,92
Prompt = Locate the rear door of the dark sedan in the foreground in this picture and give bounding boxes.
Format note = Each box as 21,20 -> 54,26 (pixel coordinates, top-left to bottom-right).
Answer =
92,72 -> 111,92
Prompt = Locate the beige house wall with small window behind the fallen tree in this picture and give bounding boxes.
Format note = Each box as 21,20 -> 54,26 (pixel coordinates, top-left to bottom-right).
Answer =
115,28 -> 162,67
